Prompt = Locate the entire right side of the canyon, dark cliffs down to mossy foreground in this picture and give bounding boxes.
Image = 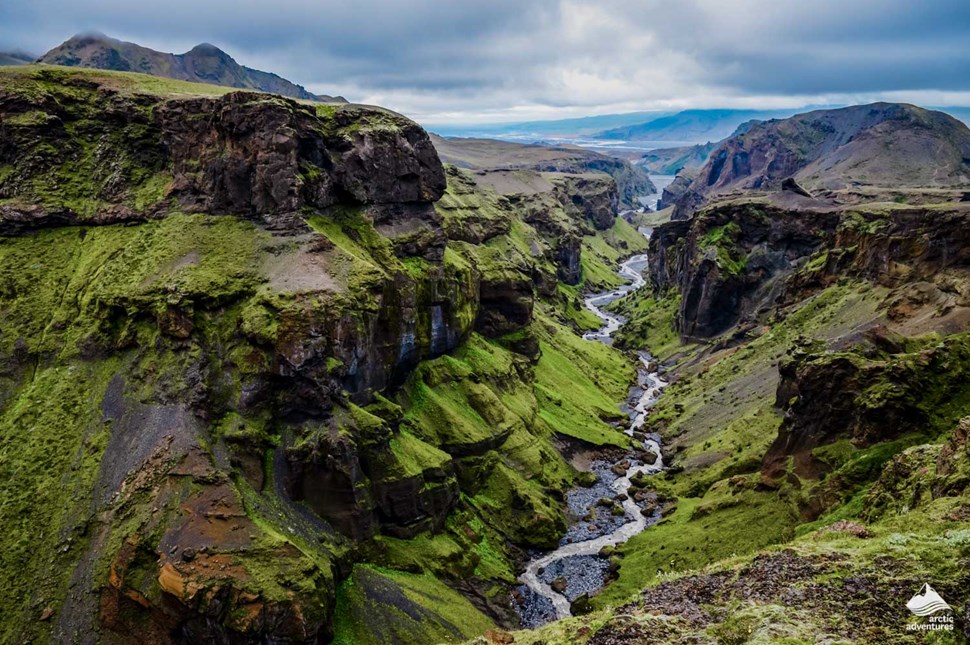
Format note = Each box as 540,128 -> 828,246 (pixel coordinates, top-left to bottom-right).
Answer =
474,182 -> 970,645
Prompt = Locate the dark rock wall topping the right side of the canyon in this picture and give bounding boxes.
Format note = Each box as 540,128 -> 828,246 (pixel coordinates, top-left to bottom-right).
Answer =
650,202 -> 970,338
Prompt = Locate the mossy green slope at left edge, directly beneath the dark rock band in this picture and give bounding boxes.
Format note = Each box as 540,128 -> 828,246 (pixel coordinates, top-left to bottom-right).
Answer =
0,215 -> 267,357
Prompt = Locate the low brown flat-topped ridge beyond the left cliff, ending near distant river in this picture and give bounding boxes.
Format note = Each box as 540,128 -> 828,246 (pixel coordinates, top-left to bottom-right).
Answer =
431,134 -> 657,208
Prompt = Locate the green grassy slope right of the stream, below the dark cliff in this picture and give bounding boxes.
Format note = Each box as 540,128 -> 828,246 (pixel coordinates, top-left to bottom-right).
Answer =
584,284 -> 884,607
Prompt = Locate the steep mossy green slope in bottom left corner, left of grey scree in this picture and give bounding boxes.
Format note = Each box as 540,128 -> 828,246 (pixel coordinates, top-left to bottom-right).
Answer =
0,360 -> 120,642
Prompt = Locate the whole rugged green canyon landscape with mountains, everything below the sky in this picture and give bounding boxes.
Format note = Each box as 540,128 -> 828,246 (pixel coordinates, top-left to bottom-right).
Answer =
0,30 -> 970,645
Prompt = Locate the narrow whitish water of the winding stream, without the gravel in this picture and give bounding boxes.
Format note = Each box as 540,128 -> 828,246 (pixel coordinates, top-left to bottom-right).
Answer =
519,230 -> 667,619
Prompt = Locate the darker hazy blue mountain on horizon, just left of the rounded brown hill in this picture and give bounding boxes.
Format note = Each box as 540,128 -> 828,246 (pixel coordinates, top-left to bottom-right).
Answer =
594,110 -> 797,143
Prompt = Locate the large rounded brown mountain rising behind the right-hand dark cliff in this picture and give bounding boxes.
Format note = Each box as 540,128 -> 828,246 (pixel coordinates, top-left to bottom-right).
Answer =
688,103 -> 970,203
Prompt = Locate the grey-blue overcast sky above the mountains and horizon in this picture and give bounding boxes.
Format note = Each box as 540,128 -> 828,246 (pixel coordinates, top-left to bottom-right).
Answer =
0,0 -> 970,124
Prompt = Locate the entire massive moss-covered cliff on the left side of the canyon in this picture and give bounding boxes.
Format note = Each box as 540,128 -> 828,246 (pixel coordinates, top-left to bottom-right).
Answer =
0,68 -> 629,642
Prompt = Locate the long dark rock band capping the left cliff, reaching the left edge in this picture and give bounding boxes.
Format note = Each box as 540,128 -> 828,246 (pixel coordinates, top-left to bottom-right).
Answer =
0,81 -> 445,234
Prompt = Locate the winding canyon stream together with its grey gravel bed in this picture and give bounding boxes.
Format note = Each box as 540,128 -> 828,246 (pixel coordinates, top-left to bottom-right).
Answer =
517,229 -> 667,627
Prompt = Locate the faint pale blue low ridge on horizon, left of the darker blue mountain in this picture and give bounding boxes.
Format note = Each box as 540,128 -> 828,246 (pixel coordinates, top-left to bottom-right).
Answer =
424,112 -> 671,140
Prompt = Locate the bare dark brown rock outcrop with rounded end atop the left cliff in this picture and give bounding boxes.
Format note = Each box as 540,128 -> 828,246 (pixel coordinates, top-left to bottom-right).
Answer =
156,92 -> 445,223
